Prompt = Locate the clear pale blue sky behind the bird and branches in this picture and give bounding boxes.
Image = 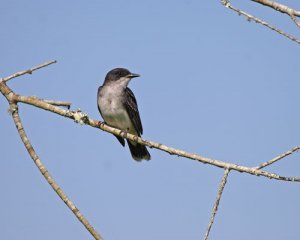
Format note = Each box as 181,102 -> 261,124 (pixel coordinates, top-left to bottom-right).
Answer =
0,0 -> 300,240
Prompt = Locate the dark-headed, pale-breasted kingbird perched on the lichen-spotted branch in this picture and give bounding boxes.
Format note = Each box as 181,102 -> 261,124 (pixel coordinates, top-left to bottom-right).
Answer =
97,68 -> 151,161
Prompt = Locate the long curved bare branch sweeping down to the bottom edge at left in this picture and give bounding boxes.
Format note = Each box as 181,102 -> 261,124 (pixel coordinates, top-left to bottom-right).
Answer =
10,103 -> 102,240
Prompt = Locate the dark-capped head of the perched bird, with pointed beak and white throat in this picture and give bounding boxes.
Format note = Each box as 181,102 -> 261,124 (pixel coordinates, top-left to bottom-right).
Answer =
104,68 -> 140,87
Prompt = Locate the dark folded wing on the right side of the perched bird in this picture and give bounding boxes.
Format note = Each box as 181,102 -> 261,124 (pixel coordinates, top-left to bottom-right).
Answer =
124,88 -> 143,136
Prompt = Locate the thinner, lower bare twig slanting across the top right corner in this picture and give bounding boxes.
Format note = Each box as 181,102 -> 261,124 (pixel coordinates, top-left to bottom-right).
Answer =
221,0 -> 300,44
